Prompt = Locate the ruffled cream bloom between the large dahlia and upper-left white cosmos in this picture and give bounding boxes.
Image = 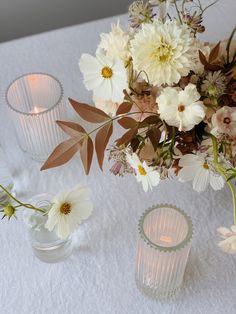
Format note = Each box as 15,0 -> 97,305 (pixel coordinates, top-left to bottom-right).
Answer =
98,22 -> 130,65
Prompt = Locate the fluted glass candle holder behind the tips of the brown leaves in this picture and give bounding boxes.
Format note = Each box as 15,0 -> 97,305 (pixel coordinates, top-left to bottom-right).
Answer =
6,73 -> 65,161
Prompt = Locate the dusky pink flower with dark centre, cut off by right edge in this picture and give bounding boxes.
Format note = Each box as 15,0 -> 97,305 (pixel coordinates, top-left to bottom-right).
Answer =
212,106 -> 236,136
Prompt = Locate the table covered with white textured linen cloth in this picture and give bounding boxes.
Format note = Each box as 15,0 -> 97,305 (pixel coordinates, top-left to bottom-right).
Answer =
0,0 -> 236,314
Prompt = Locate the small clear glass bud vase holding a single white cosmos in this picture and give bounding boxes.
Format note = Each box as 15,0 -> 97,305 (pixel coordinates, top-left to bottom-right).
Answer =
24,194 -> 73,263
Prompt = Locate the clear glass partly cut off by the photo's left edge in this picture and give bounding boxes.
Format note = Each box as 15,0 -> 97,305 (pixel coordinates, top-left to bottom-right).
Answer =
0,145 -> 14,207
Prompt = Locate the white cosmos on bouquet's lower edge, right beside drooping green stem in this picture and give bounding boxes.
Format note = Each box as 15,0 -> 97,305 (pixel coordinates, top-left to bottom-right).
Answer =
178,154 -> 225,192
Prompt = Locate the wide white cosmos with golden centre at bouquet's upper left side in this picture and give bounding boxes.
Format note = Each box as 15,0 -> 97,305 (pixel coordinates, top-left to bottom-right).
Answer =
79,53 -> 127,103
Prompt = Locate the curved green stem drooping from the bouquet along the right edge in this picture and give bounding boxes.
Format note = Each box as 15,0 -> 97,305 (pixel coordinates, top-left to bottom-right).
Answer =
211,135 -> 236,225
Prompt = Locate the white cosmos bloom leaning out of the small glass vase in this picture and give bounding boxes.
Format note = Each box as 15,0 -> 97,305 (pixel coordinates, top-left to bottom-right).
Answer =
45,187 -> 93,239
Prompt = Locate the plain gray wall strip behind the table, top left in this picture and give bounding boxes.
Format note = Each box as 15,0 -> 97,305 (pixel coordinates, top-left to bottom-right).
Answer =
0,0 -> 132,42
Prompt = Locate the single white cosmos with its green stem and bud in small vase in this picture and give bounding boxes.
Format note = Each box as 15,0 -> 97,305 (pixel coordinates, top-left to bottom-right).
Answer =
0,185 -> 93,239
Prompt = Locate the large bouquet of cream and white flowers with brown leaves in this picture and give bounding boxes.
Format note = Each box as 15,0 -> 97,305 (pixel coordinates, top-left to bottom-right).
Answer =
39,0 -> 236,253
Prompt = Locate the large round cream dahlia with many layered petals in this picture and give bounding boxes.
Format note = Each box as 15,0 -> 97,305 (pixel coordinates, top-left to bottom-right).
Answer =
131,21 -> 198,85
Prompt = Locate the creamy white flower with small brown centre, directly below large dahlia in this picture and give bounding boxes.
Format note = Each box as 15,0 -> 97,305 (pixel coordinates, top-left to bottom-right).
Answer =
157,83 -> 205,131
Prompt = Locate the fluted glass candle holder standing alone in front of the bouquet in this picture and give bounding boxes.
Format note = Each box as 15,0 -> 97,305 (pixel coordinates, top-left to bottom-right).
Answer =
136,205 -> 193,299
